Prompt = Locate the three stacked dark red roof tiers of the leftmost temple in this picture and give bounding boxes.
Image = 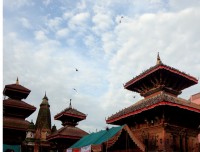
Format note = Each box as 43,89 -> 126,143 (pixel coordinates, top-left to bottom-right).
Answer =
3,78 -> 36,130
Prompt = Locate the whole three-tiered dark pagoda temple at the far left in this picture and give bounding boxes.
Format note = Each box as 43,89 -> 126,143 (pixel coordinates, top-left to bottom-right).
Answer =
3,78 -> 36,150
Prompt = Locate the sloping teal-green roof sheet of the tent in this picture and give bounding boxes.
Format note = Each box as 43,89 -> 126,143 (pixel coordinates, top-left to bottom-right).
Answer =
70,126 -> 124,148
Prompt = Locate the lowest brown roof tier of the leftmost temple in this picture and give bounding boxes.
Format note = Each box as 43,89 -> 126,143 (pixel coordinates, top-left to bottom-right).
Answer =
3,116 -> 29,131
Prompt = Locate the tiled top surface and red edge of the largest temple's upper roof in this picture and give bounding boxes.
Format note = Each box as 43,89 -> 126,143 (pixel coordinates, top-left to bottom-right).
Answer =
125,63 -> 198,88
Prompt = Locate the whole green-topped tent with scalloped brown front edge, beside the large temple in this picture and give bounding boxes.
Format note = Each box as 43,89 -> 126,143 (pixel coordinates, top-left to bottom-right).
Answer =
67,125 -> 145,152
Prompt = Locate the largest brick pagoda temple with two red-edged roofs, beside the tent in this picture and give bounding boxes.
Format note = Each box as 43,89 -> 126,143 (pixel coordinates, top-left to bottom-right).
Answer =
106,54 -> 200,152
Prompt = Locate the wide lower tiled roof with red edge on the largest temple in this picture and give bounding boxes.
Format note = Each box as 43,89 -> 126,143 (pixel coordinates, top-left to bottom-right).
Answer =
106,93 -> 200,123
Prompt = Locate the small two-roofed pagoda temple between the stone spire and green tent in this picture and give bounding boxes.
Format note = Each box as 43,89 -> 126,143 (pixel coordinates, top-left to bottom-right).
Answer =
47,99 -> 88,152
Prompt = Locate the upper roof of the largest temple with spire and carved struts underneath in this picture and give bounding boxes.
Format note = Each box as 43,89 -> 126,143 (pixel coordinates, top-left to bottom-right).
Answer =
124,52 -> 198,97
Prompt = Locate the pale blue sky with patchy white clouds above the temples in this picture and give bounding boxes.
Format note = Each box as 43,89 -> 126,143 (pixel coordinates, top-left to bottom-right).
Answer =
3,0 -> 200,132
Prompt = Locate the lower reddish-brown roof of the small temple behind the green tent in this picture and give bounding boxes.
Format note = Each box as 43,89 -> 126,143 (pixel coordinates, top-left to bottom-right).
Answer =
47,125 -> 88,140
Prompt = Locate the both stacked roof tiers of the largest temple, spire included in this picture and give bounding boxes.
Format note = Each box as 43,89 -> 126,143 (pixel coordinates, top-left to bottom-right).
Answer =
106,54 -> 200,125
